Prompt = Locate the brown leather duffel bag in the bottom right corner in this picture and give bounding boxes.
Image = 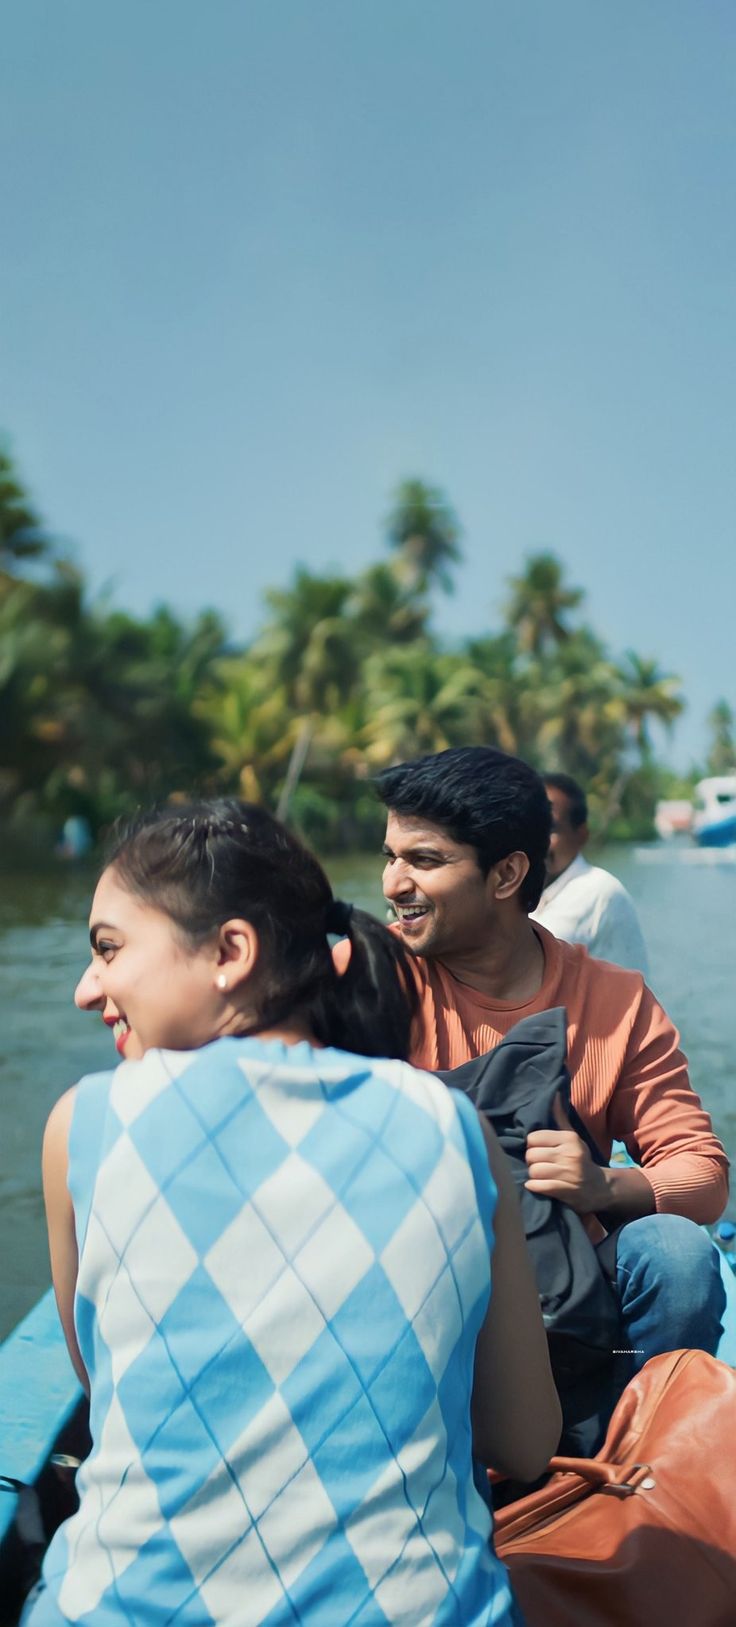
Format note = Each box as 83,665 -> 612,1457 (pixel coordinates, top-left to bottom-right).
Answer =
495,1350 -> 736,1627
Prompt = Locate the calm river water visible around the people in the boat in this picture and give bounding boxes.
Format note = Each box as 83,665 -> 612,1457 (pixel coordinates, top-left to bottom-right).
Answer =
0,846 -> 736,1337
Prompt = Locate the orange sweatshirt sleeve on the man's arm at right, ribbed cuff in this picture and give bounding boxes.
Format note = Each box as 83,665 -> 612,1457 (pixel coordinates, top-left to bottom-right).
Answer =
609,984 -> 728,1225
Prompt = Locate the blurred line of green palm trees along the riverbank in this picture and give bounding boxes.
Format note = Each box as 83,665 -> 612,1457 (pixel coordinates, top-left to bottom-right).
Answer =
0,452 -> 726,849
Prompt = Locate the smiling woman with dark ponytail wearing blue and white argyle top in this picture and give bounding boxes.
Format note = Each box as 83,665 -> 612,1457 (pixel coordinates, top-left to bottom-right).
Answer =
24,802 -> 559,1627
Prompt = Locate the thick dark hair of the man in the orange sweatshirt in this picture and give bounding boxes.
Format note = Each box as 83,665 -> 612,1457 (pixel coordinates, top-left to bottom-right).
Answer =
376,745 -> 552,909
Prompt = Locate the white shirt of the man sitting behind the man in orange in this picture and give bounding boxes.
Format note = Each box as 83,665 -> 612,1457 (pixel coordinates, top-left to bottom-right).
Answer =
531,853 -> 648,976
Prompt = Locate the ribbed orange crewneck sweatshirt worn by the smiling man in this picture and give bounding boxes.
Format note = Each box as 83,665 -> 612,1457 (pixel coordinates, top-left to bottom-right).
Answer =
410,924 -> 728,1224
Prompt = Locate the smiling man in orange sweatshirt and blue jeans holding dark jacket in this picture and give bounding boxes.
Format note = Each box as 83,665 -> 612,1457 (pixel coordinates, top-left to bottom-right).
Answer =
378,747 -> 728,1370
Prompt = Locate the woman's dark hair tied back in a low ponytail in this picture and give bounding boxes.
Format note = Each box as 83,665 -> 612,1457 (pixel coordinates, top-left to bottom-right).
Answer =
106,799 -> 418,1058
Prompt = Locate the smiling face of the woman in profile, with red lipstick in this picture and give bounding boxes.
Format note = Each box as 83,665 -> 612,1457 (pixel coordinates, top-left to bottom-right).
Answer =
75,867 -> 221,1059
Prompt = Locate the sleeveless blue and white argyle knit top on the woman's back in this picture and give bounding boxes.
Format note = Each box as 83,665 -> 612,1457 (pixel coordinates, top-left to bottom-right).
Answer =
31,1040 -> 513,1627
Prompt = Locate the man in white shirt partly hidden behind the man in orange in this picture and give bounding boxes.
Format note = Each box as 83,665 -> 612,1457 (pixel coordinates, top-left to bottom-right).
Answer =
531,774 -> 648,976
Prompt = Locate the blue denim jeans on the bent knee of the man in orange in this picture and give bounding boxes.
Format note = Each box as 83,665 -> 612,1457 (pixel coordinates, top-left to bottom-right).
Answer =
616,1214 -> 726,1373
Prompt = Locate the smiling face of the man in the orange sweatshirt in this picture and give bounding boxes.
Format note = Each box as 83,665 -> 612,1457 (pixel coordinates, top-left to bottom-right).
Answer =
383,812 -> 493,957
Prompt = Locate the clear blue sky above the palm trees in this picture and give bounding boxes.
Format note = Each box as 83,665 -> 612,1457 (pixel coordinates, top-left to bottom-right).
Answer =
0,0 -> 736,763
